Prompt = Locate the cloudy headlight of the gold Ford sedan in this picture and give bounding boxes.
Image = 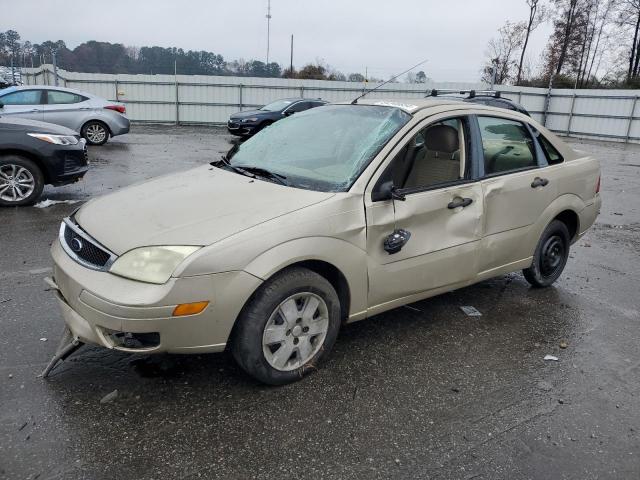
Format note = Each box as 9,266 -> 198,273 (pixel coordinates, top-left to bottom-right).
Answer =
109,246 -> 200,284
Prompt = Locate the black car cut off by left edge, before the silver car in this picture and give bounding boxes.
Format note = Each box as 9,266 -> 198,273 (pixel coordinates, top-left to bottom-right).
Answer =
0,117 -> 89,207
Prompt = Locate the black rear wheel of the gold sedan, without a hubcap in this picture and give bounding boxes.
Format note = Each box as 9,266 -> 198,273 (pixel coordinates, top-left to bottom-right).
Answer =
522,220 -> 571,288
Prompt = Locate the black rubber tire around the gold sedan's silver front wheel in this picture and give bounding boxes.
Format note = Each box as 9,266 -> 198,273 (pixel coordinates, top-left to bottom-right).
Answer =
231,267 -> 340,385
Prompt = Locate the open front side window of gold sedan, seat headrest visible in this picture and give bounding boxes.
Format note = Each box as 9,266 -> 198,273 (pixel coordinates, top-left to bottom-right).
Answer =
392,118 -> 465,189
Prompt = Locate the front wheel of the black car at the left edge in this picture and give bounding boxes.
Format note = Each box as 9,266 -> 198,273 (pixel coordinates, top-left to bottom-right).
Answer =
0,155 -> 44,207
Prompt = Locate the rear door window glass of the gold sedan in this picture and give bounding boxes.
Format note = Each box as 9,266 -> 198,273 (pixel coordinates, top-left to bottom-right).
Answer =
478,117 -> 537,175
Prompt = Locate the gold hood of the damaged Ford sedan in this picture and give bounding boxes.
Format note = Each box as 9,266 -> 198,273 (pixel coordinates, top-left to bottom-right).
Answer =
75,166 -> 333,255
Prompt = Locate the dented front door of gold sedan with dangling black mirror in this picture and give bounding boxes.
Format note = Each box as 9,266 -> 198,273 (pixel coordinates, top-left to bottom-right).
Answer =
365,117 -> 483,313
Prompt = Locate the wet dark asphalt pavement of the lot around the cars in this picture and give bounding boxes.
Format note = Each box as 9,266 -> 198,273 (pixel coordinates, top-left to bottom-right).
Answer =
0,126 -> 640,480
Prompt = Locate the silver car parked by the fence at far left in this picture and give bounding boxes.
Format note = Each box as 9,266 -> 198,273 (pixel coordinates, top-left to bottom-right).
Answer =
0,85 -> 129,145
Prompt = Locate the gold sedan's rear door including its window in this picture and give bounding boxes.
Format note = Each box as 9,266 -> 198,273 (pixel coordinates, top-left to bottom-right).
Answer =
476,115 -> 557,274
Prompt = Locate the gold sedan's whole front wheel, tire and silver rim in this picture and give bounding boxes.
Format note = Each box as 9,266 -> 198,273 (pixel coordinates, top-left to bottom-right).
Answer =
231,267 -> 340,385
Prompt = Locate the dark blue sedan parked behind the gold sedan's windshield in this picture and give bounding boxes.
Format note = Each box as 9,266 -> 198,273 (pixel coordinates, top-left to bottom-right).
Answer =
227,98 -> 327,137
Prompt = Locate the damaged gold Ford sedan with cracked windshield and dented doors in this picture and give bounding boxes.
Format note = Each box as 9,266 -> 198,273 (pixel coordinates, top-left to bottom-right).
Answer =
45,99 -> 600,384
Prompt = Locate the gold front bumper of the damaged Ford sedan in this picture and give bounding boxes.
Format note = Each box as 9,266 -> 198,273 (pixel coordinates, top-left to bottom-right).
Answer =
50,240 -> 261,353
